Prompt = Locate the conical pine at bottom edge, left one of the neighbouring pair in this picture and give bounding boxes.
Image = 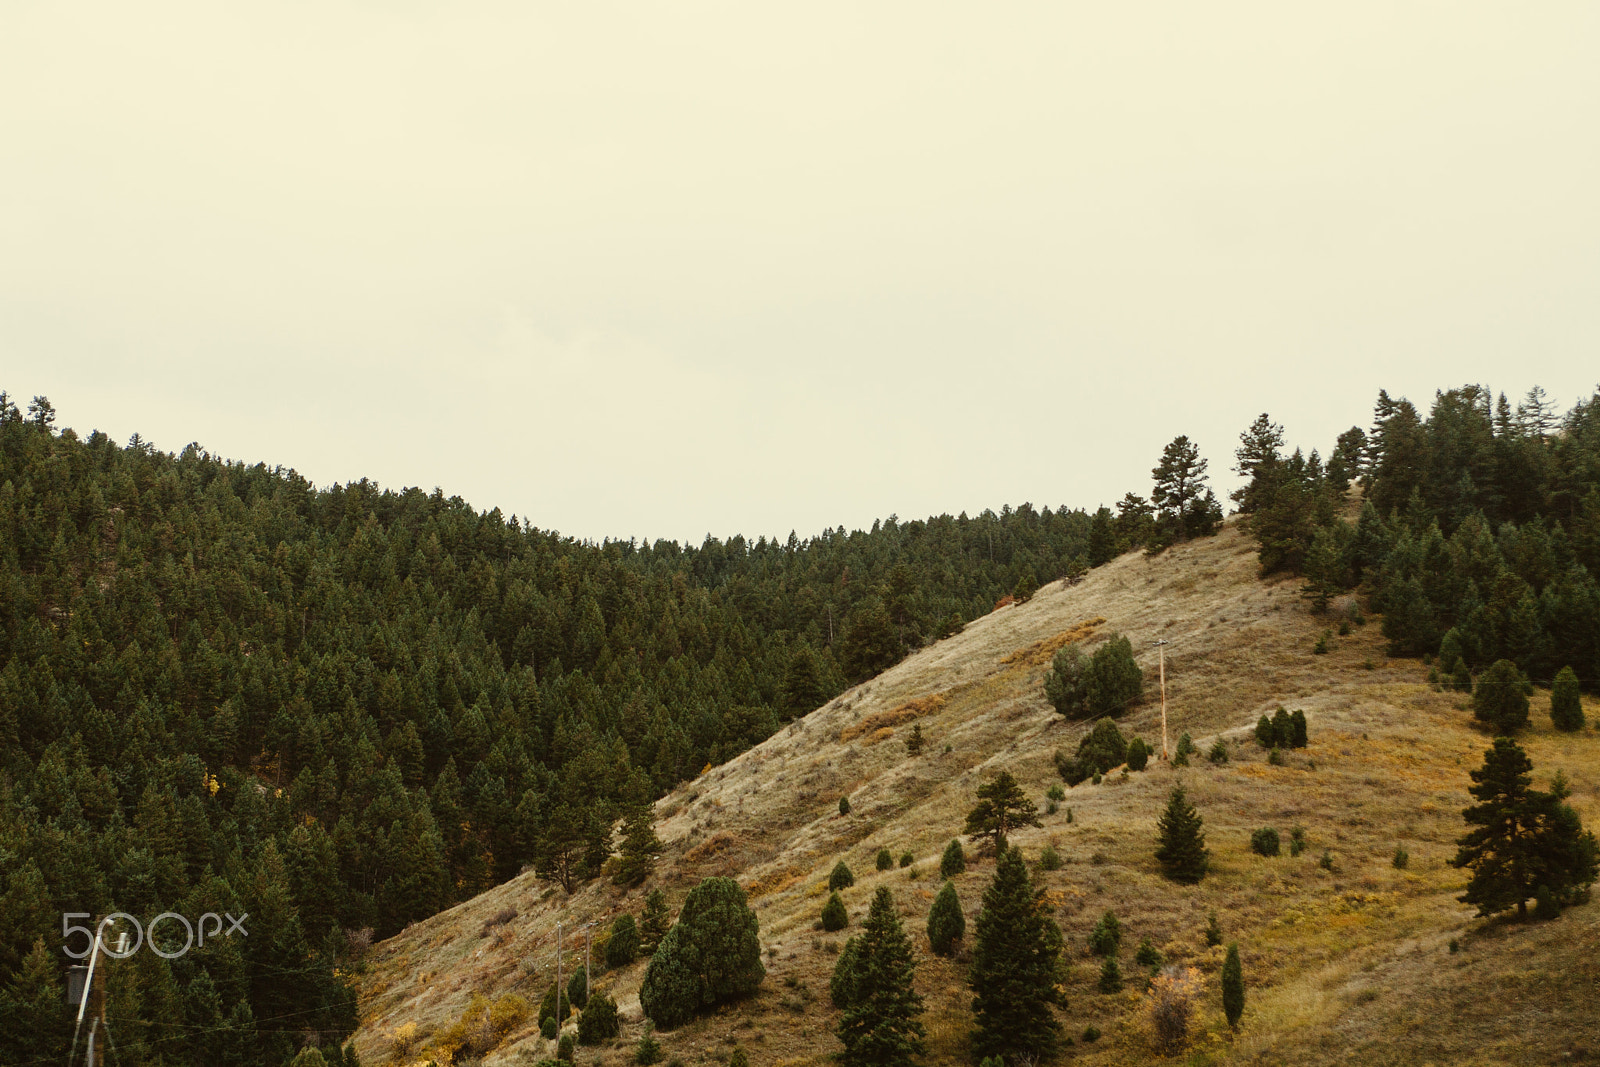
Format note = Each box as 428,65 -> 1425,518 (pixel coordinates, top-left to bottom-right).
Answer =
835,886 -> 926,1067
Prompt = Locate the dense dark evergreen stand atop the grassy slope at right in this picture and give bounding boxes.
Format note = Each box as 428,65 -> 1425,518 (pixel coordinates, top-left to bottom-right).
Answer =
1235,386 -> 1600,691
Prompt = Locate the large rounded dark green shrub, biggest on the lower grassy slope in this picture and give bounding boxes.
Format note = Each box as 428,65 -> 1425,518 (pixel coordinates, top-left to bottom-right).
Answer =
638,878 -> 766,1027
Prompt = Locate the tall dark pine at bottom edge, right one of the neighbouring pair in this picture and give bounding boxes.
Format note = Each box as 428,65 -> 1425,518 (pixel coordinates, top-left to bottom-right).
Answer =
966,848 -> 1066,1062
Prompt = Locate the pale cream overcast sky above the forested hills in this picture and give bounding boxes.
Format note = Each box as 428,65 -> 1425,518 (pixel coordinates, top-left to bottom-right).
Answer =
0,0 -> 1600,542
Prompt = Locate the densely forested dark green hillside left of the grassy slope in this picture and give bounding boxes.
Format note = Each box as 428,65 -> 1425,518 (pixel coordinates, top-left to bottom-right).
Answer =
0,394 -> 1155,1064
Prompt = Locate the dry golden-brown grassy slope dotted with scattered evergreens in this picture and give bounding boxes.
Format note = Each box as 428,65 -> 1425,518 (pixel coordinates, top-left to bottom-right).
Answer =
358,526 -> 1600,1065
